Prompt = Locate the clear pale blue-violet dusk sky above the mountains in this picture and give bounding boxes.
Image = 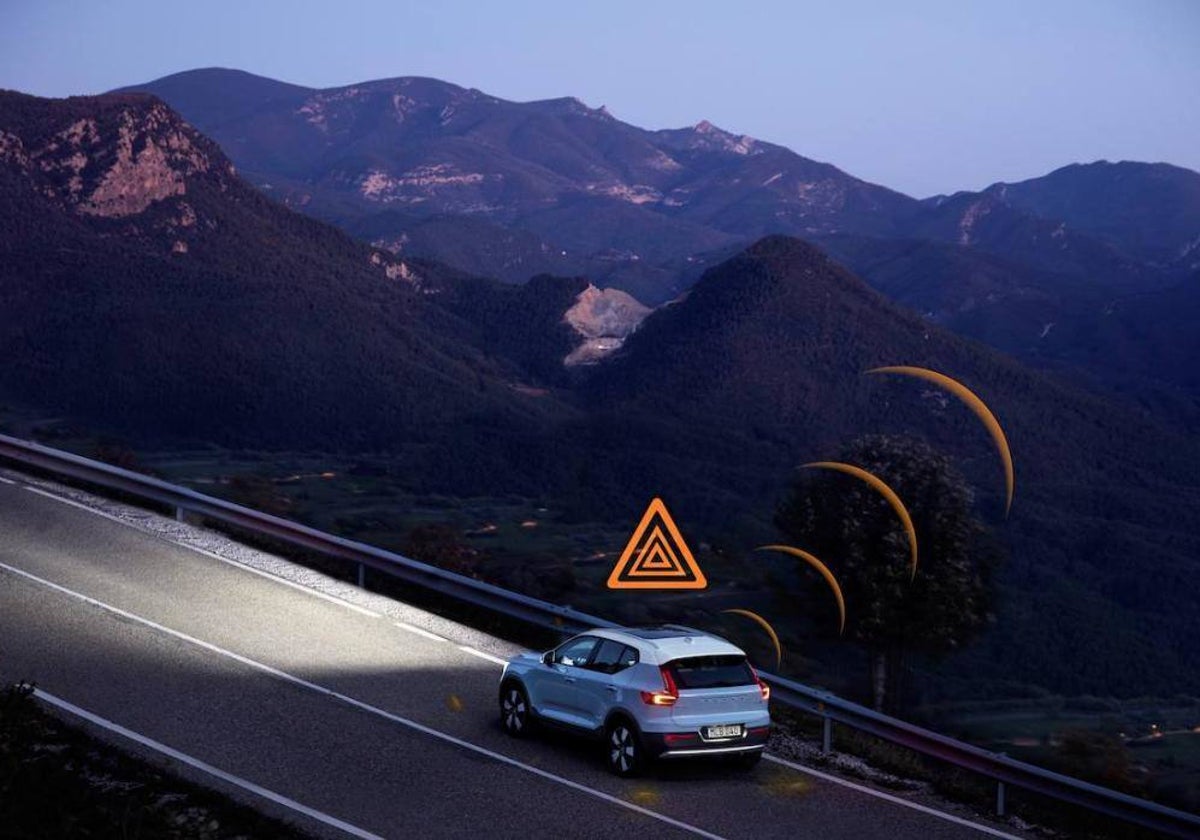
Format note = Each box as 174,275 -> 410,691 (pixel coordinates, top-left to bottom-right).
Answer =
0,0 -> 1200,197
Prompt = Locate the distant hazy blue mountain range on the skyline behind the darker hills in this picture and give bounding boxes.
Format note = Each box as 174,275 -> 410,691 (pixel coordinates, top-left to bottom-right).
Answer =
117,68 -> 1200,408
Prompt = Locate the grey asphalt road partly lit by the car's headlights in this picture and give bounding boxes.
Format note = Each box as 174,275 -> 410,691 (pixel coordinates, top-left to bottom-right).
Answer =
0,481 -> 1032,840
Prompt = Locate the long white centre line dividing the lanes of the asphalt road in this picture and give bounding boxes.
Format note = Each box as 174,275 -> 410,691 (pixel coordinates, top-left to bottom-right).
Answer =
0,563 -> 725,840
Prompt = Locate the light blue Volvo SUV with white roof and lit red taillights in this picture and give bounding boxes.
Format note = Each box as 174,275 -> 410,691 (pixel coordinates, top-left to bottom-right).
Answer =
499,624 -> 770,776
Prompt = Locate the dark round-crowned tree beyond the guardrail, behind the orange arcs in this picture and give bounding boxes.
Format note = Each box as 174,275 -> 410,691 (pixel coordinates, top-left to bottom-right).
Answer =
775,436 -> 1000,712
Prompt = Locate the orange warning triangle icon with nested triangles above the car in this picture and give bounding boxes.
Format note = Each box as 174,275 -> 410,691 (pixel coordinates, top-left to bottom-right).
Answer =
608,498 -> 708,589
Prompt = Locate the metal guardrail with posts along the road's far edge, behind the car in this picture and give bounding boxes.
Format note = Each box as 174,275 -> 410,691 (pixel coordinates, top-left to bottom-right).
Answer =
0,434 -> 1200,838
